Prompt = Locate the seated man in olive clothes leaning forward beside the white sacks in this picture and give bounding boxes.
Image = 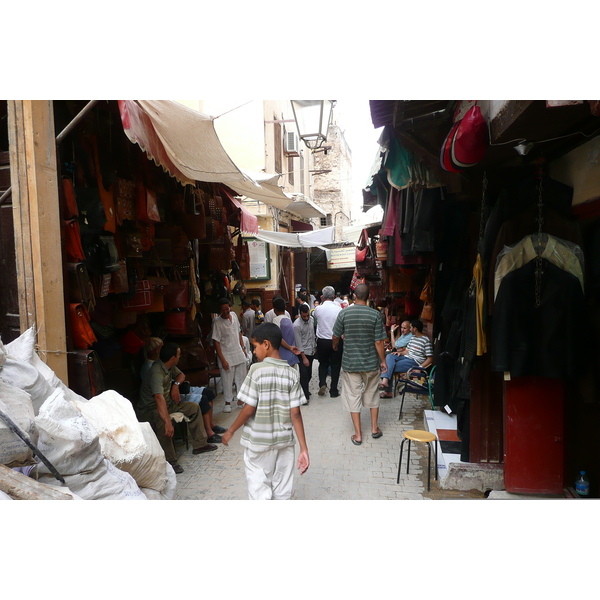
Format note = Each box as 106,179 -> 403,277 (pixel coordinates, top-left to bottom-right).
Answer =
136,343 -> 217,473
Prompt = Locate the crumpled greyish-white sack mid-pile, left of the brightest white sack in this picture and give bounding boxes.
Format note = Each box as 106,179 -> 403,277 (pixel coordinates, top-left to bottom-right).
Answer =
35,390 -> 104,478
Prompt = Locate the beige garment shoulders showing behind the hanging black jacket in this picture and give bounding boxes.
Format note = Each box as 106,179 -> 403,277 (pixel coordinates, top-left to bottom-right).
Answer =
494,234 -> 584,300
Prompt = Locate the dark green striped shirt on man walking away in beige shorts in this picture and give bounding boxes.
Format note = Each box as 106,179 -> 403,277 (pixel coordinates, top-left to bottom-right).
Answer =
333,304 -> 387,373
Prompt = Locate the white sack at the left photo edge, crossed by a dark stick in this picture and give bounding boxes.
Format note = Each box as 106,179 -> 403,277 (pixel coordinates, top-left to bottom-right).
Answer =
0,380 -> 37,467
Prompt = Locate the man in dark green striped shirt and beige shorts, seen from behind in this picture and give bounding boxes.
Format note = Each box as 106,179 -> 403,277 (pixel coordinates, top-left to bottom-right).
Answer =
332,283 -> 387,446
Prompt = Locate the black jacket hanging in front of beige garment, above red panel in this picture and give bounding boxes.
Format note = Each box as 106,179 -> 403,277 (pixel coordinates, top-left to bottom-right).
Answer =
491,258 -> 585,378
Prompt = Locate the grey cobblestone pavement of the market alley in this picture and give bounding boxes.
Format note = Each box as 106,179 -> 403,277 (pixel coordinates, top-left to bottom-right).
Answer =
175,361 -> 484,500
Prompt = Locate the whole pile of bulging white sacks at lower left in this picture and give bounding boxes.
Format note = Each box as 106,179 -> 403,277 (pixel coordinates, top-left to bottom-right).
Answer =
0,328 -> 176,500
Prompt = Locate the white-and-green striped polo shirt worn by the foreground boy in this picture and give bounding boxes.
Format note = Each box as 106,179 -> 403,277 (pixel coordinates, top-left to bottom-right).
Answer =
238,357 -> 304,452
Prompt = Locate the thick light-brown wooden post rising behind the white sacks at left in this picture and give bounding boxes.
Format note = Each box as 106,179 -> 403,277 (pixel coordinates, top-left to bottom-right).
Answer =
8,100 -> 68,385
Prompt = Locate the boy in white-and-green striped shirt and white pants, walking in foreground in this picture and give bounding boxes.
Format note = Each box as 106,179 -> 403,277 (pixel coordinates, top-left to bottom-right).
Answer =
222,323 -> 310,500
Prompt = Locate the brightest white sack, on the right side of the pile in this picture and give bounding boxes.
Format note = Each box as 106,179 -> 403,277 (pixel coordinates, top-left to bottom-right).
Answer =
75,390 -> 147,466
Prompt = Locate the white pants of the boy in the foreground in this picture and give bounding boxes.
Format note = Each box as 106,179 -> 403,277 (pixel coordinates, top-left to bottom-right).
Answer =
244,446 -> 295,500
